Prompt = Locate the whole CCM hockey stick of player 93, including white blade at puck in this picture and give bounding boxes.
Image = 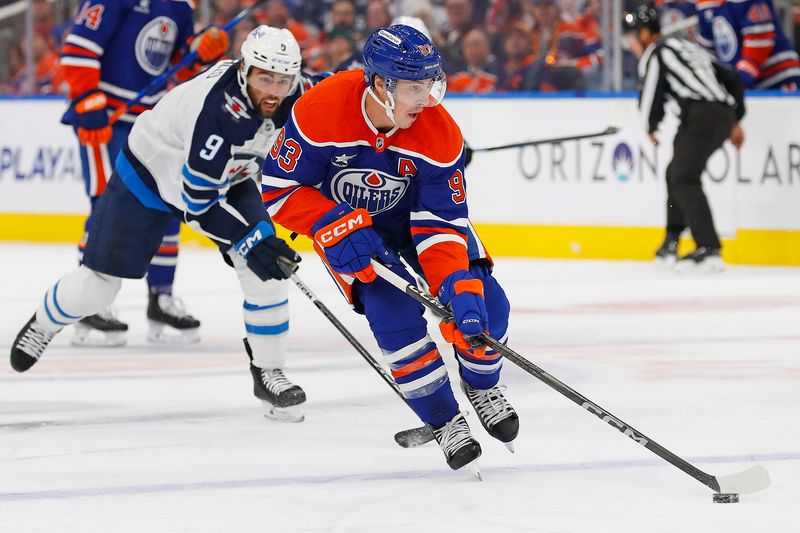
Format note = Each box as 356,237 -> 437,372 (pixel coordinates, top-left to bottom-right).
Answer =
372,259 -> 770,494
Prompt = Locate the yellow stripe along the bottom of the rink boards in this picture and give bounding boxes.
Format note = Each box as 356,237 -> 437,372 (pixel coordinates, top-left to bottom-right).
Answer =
0,213 -> 800,265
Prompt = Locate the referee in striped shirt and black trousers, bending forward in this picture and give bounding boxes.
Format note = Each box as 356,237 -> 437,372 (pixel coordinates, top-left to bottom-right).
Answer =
622,5 -> 744,271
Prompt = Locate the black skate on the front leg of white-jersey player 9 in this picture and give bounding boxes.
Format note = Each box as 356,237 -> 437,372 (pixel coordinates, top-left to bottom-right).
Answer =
244,339 -> 306,422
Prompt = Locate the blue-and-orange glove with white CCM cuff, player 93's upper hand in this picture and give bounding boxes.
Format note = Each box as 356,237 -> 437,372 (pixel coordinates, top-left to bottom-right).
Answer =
311,203 -> 393,283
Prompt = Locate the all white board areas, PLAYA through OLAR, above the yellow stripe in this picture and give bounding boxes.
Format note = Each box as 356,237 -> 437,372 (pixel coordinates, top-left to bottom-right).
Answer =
0,96 -> 800,236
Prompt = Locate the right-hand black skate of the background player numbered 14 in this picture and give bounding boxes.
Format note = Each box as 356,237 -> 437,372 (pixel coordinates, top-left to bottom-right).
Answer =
147,292 -> 200,344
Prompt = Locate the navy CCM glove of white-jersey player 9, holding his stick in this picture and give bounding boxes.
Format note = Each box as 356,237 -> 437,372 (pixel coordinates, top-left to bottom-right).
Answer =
238,221 -> 301,281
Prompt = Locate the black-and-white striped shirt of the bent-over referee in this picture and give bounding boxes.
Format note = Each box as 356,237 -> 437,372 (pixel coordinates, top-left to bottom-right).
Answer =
639,37 -> 737,133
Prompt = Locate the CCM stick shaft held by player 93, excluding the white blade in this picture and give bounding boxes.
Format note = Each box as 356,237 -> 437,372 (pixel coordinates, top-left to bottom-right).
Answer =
372,259 -> 719,492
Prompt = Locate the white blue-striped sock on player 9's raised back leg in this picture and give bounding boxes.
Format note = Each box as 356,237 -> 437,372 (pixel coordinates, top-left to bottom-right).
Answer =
36,265 -> 122,332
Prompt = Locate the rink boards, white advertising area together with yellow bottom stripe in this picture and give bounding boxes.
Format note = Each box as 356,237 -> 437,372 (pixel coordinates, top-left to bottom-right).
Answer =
0,93 -> 800,265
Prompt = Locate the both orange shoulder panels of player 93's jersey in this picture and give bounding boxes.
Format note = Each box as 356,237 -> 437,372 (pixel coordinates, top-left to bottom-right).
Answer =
293,69 -> 463,164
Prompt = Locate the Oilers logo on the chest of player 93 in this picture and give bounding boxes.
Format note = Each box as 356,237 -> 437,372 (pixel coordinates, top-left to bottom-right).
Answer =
331,168 -> 409,215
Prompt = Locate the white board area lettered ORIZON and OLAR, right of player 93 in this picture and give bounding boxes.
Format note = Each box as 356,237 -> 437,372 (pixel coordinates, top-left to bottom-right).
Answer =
447,97 -> 800,235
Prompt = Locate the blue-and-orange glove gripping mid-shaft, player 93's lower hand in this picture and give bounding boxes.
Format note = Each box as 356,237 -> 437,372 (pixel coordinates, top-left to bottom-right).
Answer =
439,270 -> 489,358
